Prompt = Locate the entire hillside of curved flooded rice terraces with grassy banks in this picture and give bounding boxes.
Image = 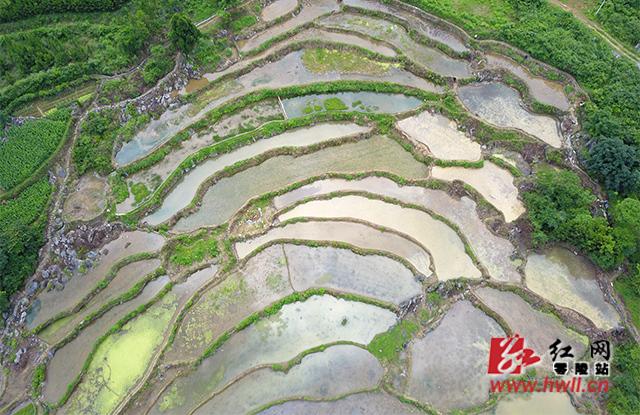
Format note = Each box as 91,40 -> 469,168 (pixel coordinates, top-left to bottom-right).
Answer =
15,0 -> 622,415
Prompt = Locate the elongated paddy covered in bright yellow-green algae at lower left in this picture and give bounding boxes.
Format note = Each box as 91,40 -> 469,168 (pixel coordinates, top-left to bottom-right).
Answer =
65,293 -> 178,414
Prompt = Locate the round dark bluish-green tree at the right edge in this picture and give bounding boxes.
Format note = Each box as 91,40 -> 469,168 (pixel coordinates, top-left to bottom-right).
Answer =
587,137 -> 640,195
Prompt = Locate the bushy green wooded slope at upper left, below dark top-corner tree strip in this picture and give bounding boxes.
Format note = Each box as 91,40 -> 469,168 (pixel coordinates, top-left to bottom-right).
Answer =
0,0 -> 164,113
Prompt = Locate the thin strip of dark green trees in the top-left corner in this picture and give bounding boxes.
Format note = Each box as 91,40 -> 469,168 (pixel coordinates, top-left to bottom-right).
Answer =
0,0 -> 129,22
